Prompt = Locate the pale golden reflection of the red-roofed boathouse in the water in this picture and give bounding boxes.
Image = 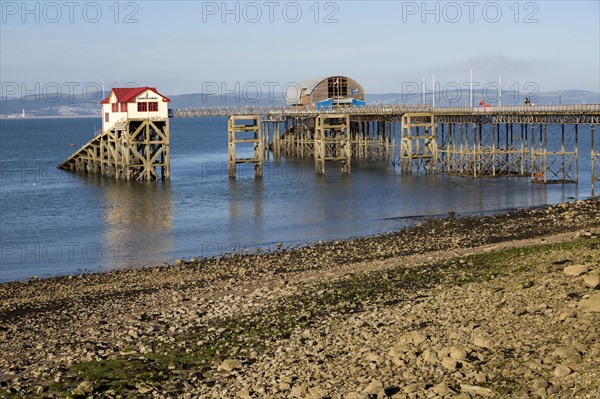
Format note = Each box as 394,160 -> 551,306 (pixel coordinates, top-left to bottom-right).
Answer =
100,179 -> 173,270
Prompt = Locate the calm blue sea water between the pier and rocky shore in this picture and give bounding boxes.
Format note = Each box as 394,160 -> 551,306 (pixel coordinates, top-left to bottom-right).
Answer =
0,118 -> 591,282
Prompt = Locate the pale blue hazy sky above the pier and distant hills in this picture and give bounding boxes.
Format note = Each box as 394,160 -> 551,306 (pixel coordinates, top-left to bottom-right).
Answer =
0,0 -> 600,96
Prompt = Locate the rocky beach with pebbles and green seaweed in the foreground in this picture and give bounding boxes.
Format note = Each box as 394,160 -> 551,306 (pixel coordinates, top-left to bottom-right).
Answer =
0,199 -> 600,399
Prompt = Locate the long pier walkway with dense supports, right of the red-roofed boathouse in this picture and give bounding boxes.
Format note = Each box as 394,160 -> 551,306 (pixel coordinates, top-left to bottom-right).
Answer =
180,104 -> 600,191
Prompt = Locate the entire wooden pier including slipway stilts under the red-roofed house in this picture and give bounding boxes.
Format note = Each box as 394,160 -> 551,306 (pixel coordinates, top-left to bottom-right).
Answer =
59,104 -> 600,190
